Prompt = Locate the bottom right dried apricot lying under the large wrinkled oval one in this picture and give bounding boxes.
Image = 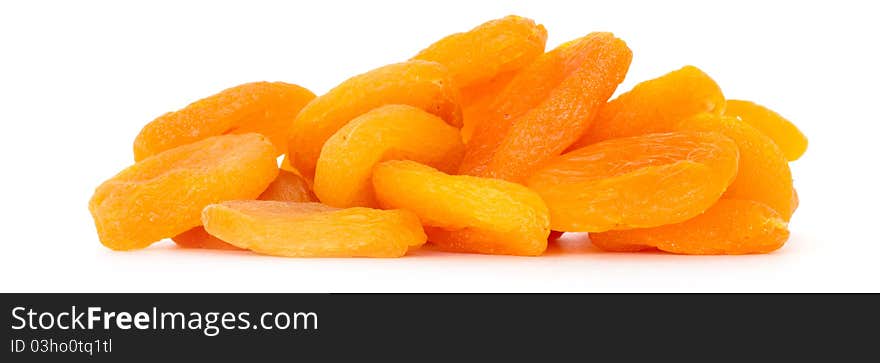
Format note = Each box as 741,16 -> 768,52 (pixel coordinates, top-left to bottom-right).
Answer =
590,199 -> 789,255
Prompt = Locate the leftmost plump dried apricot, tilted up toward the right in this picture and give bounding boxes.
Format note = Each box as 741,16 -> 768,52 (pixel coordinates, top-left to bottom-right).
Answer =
89,134 -> 278,250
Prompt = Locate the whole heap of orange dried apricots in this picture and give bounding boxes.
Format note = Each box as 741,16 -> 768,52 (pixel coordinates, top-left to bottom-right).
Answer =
89,16 -> 807,257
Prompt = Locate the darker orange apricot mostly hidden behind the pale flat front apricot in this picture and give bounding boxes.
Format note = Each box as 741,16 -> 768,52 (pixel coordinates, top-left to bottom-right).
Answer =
172,170 -> 318,250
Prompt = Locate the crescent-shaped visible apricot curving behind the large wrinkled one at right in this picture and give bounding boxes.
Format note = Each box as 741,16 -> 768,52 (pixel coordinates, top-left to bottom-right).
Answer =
679,114 -> 794,221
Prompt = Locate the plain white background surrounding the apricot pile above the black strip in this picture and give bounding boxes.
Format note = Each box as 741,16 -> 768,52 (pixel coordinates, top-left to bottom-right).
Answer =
0,0 -> 880,292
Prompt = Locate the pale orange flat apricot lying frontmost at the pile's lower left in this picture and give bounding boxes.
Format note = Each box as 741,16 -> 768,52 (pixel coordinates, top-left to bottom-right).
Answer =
202,200 -> 426,257
